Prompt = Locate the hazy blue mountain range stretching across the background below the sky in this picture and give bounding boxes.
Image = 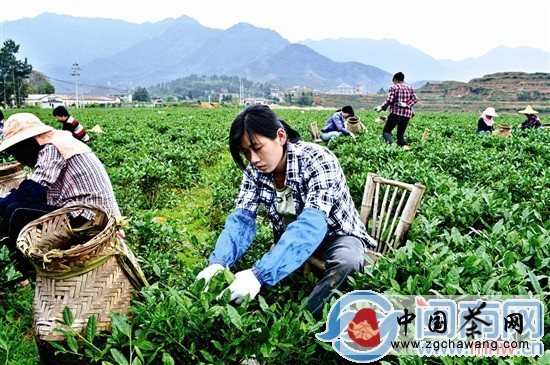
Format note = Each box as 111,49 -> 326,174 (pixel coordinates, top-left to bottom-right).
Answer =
1,13 -> 549,93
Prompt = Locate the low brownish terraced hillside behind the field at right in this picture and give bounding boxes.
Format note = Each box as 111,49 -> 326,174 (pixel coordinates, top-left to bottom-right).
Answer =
315,72 -> 550,113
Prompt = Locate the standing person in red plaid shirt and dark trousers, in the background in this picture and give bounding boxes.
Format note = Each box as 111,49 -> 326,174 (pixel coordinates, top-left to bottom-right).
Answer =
376,72 -> 418,150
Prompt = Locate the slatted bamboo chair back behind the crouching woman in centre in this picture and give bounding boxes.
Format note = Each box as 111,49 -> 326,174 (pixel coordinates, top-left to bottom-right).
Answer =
304,173 -> 426,273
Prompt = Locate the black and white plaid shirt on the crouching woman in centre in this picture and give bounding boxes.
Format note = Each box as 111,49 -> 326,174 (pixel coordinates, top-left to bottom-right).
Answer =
236,142 -> 368,242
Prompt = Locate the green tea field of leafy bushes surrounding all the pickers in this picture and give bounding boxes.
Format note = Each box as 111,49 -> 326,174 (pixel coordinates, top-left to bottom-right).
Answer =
0,108 -> 550,365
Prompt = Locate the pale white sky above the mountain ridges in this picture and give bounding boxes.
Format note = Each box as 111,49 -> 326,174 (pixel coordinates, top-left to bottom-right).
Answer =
0,0 -> 550,61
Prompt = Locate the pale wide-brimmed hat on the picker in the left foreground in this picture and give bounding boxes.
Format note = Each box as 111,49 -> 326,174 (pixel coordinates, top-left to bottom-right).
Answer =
0,113 -> 54,151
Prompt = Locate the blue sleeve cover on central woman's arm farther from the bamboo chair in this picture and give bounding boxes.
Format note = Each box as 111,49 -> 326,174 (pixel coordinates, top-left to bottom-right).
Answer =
208,209 -> 256,267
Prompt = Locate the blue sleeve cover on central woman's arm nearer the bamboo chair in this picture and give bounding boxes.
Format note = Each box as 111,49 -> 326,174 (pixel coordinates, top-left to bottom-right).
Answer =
252,208 -> 327,286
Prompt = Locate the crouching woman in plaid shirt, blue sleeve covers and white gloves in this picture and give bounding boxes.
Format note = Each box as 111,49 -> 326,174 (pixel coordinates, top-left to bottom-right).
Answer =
197,105 -> 376,319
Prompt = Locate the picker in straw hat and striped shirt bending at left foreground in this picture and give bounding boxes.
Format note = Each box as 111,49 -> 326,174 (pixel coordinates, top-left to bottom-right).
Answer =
0,113 -> 120,282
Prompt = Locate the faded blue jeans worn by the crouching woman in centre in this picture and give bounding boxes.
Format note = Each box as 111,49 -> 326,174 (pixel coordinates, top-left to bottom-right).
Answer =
306,236 -> 364,320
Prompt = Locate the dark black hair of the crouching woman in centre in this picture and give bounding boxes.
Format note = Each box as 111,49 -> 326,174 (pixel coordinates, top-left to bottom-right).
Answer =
229,104 -> 300,169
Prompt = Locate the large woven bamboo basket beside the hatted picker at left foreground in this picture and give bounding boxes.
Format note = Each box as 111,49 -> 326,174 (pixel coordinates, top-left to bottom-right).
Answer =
17,205 -> 148,342
